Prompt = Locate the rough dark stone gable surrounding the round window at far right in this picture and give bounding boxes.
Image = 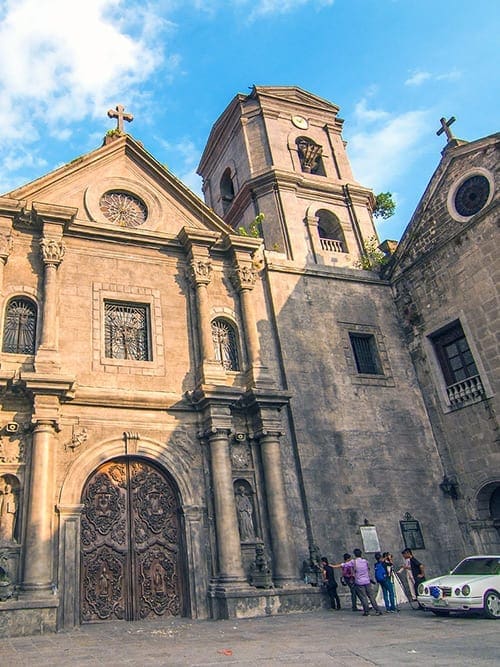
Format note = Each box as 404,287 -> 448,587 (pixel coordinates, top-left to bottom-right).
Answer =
384,134 -> 500,277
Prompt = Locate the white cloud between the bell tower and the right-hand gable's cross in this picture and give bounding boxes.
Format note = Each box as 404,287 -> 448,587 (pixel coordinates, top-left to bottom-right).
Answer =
348,100 -> 430,192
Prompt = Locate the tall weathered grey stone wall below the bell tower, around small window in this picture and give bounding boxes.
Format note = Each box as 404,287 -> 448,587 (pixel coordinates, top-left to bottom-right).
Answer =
269,260 -> 463,573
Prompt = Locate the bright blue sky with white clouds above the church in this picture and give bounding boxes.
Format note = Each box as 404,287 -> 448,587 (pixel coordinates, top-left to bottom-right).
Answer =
0,0 -> 500,240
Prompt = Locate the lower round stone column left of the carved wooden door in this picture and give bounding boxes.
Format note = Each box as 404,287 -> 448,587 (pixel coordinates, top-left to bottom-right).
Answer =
21,418 -> 56,597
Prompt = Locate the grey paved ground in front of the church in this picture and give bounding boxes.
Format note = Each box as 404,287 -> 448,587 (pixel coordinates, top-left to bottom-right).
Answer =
0,608 -> 500,667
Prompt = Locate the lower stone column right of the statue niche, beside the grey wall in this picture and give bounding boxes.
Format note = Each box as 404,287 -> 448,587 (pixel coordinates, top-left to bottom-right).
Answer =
257,431 -> 297,586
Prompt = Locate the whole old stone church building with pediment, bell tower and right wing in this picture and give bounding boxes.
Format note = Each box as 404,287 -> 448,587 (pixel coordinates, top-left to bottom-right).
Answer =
0,87 -> 500,635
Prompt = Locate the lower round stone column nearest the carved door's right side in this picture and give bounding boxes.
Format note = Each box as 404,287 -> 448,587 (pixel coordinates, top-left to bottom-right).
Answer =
205,428 -> 245,584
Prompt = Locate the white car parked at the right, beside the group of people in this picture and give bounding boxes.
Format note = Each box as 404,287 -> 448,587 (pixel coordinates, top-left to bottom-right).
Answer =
417,556 -> 500,618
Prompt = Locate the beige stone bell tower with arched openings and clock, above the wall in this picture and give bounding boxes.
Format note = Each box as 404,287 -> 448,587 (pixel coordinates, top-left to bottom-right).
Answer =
198,86 -> 376,267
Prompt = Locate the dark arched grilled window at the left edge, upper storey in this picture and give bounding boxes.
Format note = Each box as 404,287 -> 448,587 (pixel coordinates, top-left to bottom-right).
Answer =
2,297 -> 37,354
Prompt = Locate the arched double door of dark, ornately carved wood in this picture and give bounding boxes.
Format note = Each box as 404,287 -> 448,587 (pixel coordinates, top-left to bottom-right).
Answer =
80,458 -> 180,623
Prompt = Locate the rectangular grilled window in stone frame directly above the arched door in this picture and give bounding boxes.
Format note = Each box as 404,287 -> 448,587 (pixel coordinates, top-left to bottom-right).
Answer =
104,301 -> 151,361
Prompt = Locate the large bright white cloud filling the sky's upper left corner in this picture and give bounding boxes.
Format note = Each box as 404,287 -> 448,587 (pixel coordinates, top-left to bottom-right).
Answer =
0,0 -> 169,141
